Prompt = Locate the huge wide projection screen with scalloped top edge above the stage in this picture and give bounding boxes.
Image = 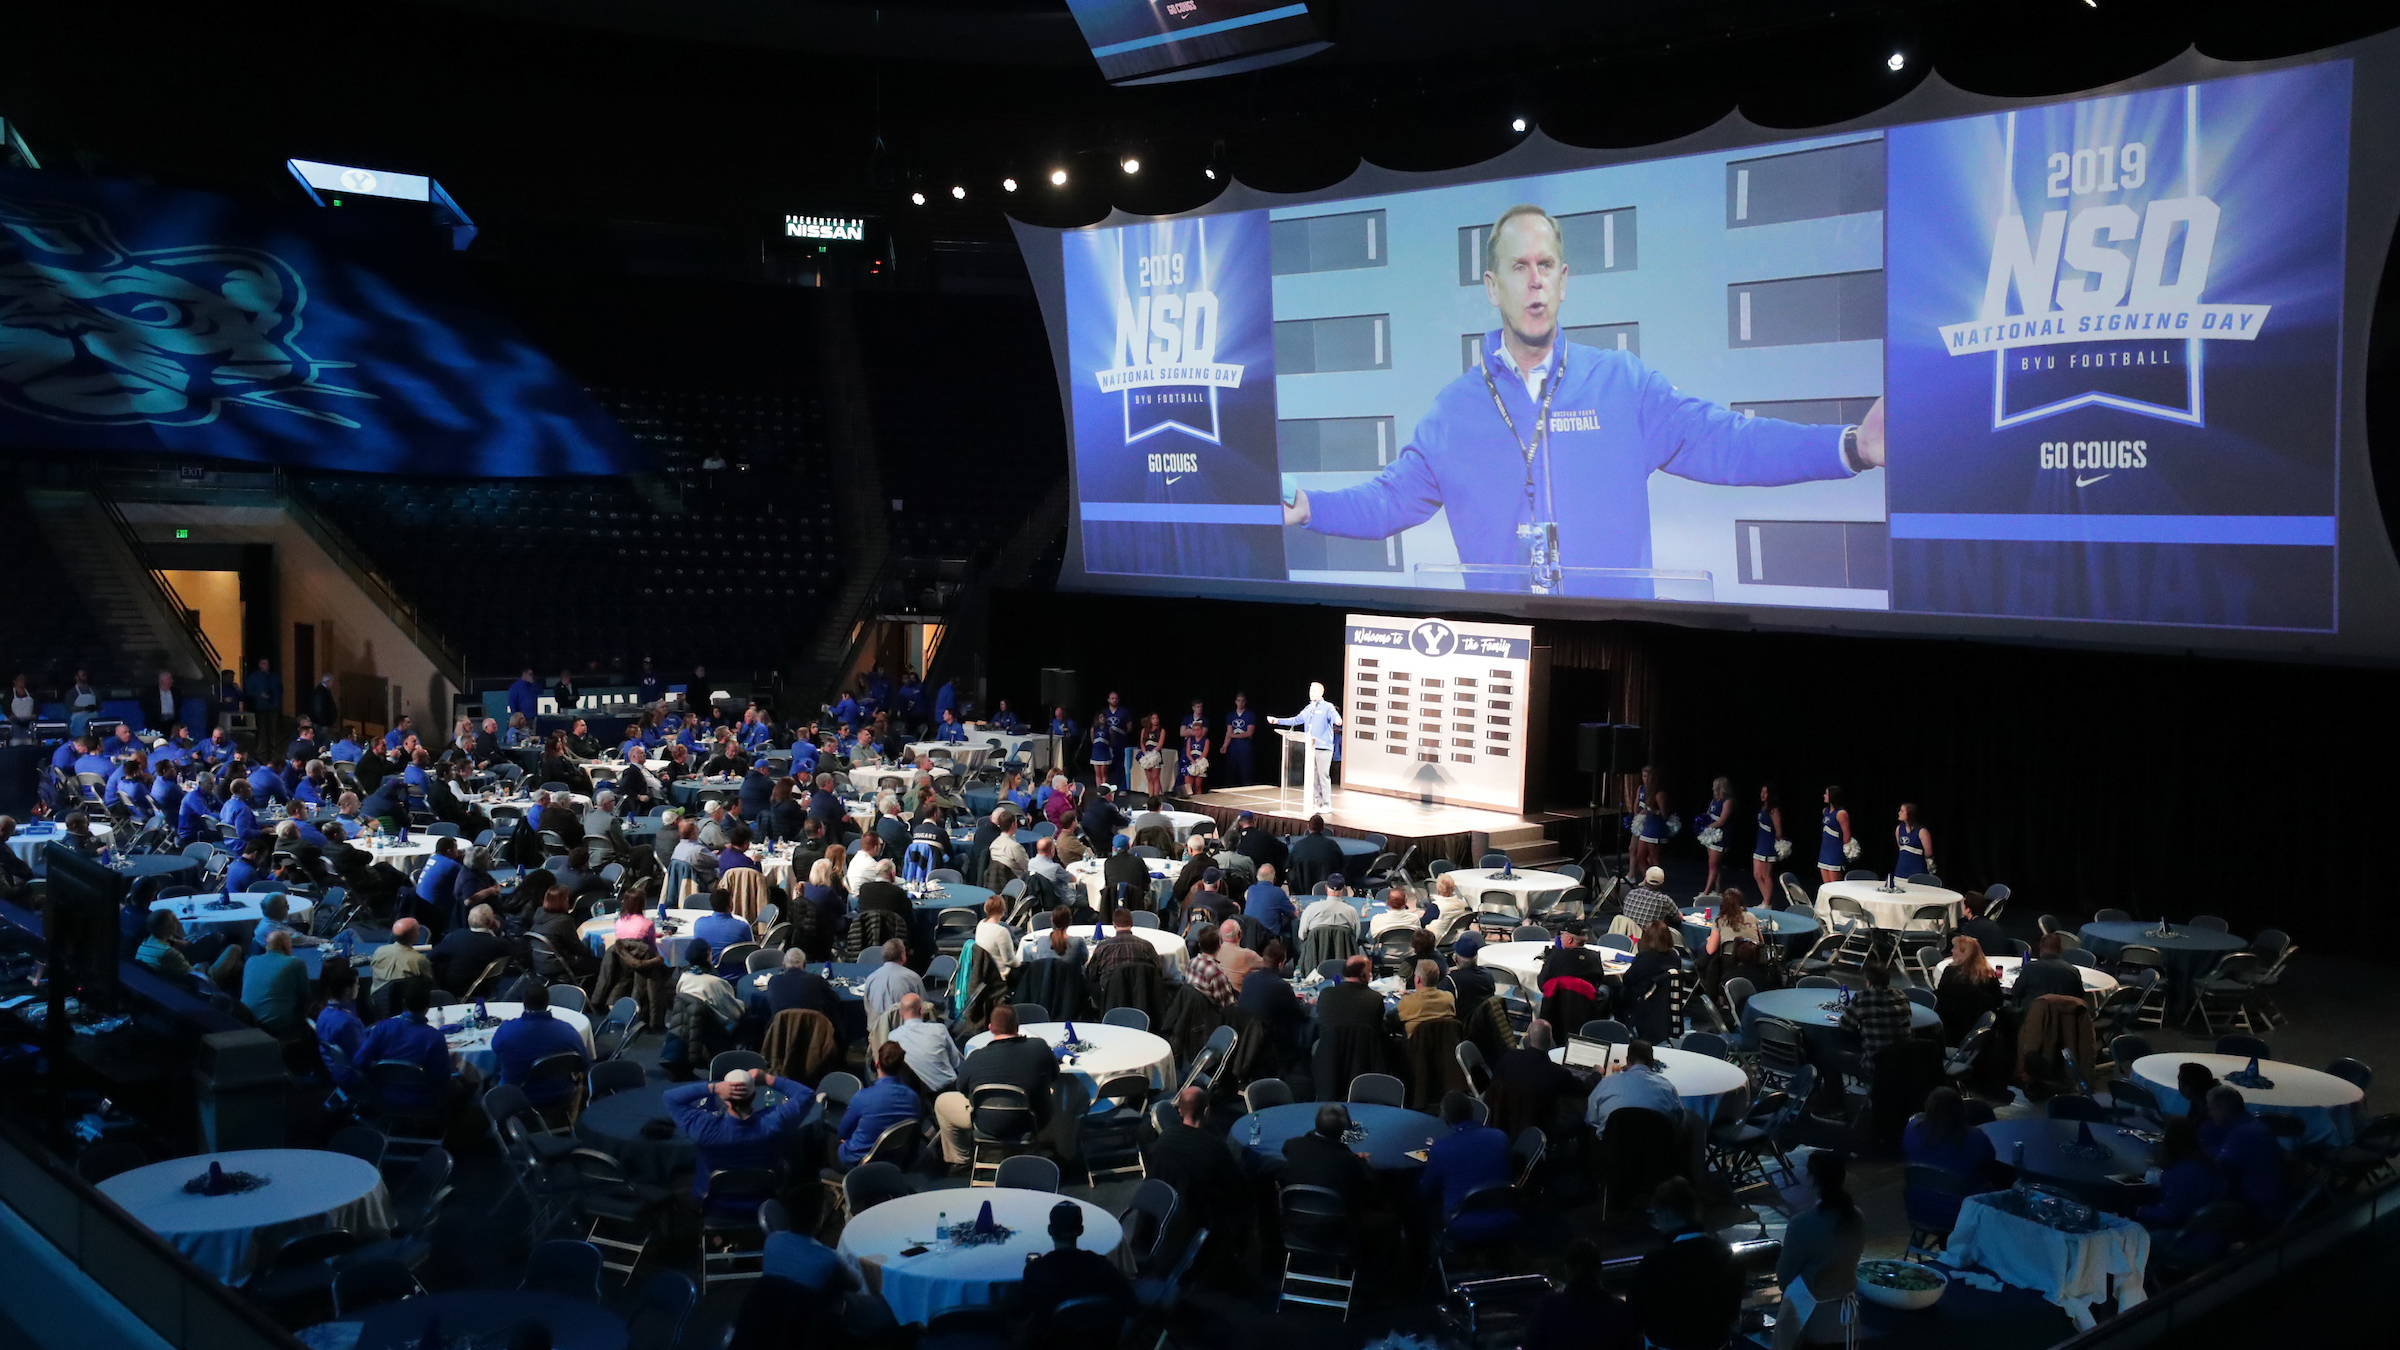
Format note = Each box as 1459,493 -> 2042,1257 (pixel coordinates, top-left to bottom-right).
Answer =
1018,44 -> 2400,661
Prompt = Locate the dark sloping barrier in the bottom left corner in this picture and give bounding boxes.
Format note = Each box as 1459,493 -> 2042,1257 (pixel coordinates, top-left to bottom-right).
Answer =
0,1119 -> 300,1350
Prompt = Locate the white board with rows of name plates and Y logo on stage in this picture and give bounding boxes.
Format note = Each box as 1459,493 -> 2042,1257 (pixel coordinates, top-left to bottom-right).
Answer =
1342,615 -> 1534,812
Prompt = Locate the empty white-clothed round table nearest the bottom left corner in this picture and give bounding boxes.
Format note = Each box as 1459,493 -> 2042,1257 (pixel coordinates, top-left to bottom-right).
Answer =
101,1148 -> 391,1285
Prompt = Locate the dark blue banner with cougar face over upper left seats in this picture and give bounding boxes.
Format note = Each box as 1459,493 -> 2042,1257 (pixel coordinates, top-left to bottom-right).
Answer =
0,173 -> 650,478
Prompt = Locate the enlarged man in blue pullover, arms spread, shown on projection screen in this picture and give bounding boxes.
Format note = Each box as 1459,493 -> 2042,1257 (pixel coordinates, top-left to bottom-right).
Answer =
1284,207 -> 1884,598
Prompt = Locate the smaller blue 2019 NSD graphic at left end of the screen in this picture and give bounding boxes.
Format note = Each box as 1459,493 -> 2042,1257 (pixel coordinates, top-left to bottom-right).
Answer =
1066,211 -> 1284,579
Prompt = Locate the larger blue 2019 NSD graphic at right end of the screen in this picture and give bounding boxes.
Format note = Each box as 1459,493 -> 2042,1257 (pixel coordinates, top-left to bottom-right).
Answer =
1886,62 -> 2352,629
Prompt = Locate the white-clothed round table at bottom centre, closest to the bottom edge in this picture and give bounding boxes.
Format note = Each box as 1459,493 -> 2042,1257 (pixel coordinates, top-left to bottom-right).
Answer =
835,1187 -> 1123,1321
